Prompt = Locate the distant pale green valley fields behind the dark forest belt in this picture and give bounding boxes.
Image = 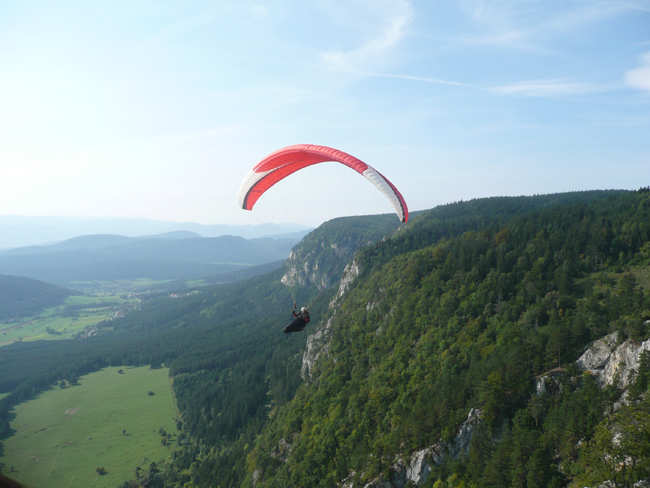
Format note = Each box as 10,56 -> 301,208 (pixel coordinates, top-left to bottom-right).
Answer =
0,295 -> 137,346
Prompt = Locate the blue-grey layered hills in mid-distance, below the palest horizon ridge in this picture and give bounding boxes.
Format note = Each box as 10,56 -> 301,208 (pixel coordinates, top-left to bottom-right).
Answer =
0,231 -> 298,284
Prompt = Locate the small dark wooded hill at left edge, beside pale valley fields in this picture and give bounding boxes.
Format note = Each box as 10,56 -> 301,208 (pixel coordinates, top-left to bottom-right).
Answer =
0,275 -> 72,322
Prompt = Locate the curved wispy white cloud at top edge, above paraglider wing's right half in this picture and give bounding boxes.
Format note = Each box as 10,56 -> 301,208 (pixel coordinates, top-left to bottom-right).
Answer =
321,1 -> 413,72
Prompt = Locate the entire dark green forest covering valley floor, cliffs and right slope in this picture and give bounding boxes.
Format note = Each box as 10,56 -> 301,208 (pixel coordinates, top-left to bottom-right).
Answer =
0,190 -> 650,488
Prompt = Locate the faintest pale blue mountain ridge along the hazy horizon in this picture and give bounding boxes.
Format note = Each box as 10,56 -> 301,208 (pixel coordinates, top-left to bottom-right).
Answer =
0,215 -> 310,249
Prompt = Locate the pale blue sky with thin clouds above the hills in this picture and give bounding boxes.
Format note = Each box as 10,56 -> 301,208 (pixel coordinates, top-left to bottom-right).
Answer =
0,0 -> 650,225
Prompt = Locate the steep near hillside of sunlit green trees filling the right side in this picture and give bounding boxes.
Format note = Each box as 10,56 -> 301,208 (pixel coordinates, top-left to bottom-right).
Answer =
244,194 -> 650,487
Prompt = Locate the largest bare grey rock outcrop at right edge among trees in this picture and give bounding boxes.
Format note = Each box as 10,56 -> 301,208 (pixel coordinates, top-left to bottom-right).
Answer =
577,332 -> 650,389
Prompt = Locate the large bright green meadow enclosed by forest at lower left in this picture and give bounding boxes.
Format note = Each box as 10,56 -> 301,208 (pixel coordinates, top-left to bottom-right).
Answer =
0,367 -> 176,488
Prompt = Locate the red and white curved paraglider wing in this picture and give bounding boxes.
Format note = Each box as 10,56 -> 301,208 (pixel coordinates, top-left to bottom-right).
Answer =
239,144 -> 408,222
